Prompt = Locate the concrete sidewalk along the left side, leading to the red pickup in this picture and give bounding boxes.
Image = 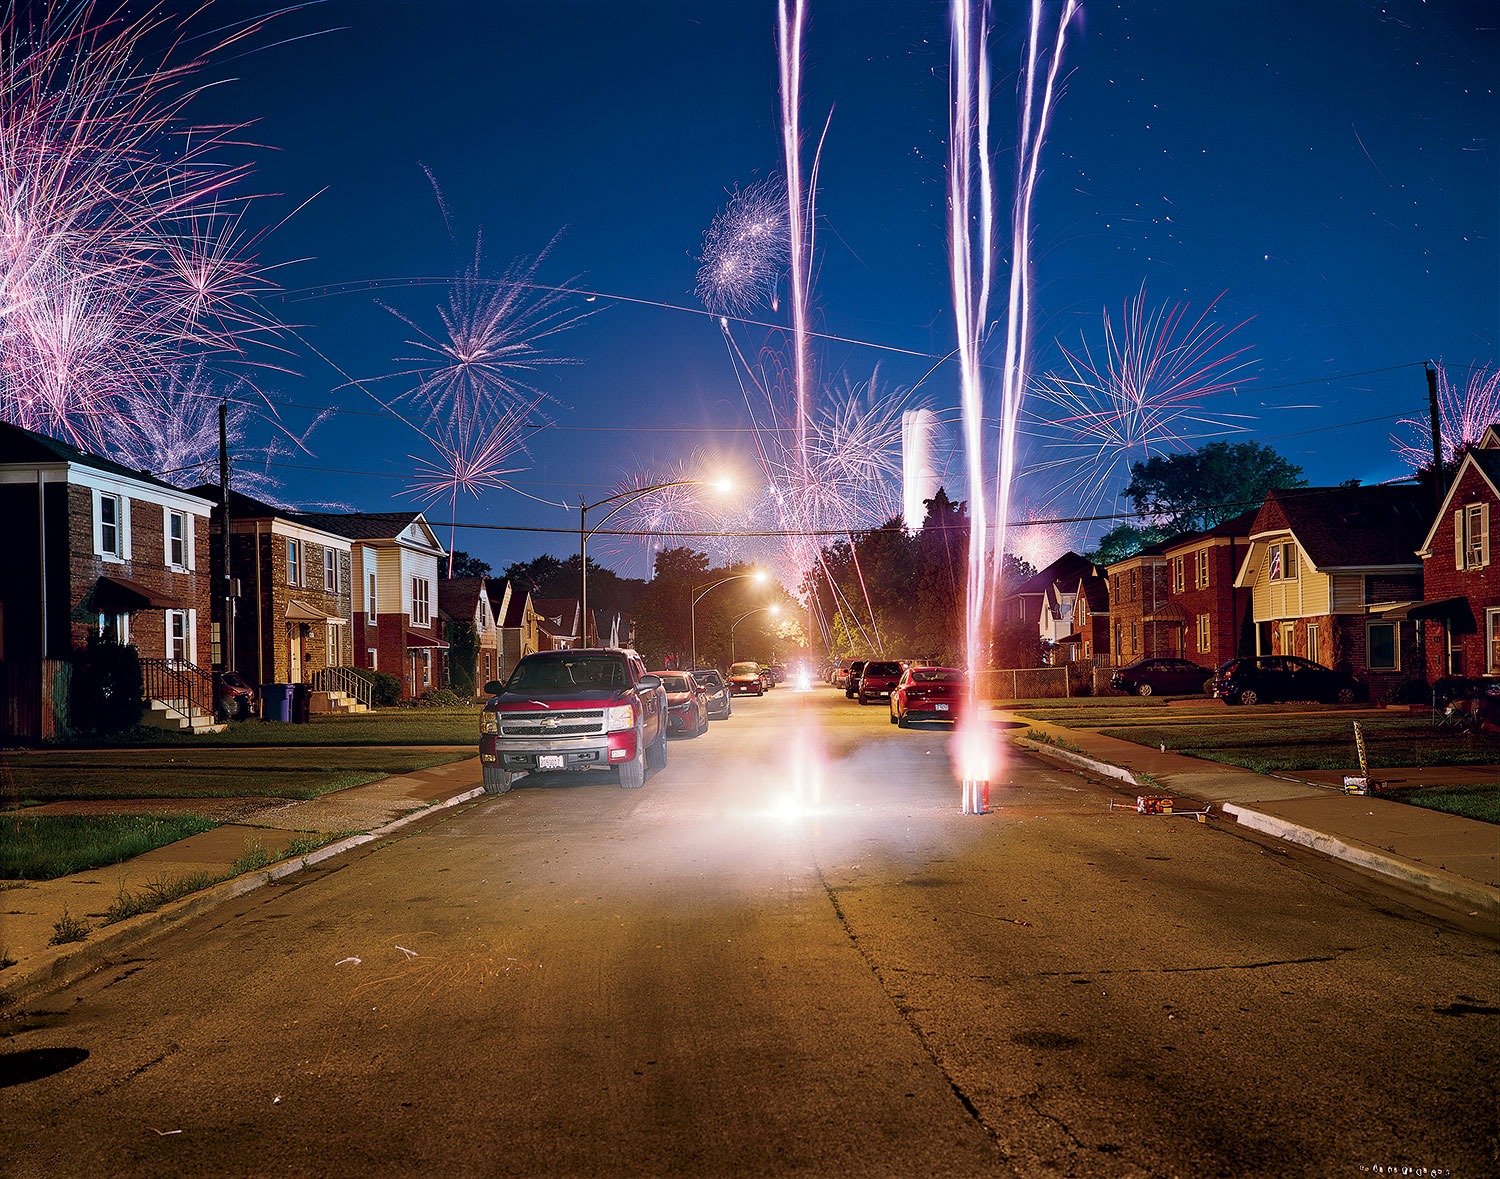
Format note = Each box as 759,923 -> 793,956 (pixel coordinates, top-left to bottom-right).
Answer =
0,756 -> 483,1014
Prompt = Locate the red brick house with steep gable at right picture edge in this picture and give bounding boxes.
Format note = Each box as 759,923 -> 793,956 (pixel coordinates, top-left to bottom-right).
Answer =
1407,447 -> 1500,681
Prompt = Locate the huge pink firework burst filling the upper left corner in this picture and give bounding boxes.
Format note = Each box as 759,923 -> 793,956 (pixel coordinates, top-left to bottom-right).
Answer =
0,0 -> 289,452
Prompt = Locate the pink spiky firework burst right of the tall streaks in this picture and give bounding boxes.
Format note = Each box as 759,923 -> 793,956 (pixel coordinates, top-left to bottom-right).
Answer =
1031,288 -> 1251,510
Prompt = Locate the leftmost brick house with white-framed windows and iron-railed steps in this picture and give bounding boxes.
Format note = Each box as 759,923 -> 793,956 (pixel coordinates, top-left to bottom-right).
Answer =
0,423 -> 215,743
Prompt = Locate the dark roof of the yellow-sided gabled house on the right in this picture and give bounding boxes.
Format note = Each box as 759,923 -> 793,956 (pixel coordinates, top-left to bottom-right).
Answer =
1251,485 -> 1431,570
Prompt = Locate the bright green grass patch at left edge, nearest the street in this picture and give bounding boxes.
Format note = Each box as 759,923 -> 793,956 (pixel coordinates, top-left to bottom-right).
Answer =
0,815 -> 218,881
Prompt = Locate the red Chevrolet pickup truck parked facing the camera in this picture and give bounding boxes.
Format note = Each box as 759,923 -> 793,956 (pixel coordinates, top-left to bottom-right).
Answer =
479,648 -> 666,794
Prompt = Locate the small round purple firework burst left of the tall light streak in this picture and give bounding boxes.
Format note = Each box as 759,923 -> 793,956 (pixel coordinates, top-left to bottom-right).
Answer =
695,177 -> 791,317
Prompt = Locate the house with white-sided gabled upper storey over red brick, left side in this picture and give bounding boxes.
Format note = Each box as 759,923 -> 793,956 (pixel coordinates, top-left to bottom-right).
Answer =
302,512 -> 449,701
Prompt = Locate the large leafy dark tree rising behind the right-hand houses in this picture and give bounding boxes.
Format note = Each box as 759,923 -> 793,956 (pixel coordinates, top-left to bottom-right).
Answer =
1122,443 -> 1308,534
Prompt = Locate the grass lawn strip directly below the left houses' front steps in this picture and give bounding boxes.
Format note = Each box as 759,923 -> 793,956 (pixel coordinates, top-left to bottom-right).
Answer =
52,705 -> 480,749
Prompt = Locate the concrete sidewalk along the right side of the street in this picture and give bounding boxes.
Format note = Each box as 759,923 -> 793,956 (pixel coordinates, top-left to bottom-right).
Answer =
995,710 -> 1500,935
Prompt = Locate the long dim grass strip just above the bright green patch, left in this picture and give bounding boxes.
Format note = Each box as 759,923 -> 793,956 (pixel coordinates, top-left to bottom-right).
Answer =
0,750 -> 467,806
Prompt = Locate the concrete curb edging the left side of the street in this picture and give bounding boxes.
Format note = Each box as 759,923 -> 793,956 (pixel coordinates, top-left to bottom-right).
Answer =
0,786 -> 485,1011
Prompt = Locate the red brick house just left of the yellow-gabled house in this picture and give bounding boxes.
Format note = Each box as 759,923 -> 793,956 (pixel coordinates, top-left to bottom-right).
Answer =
1151,509 -> 1259,671
